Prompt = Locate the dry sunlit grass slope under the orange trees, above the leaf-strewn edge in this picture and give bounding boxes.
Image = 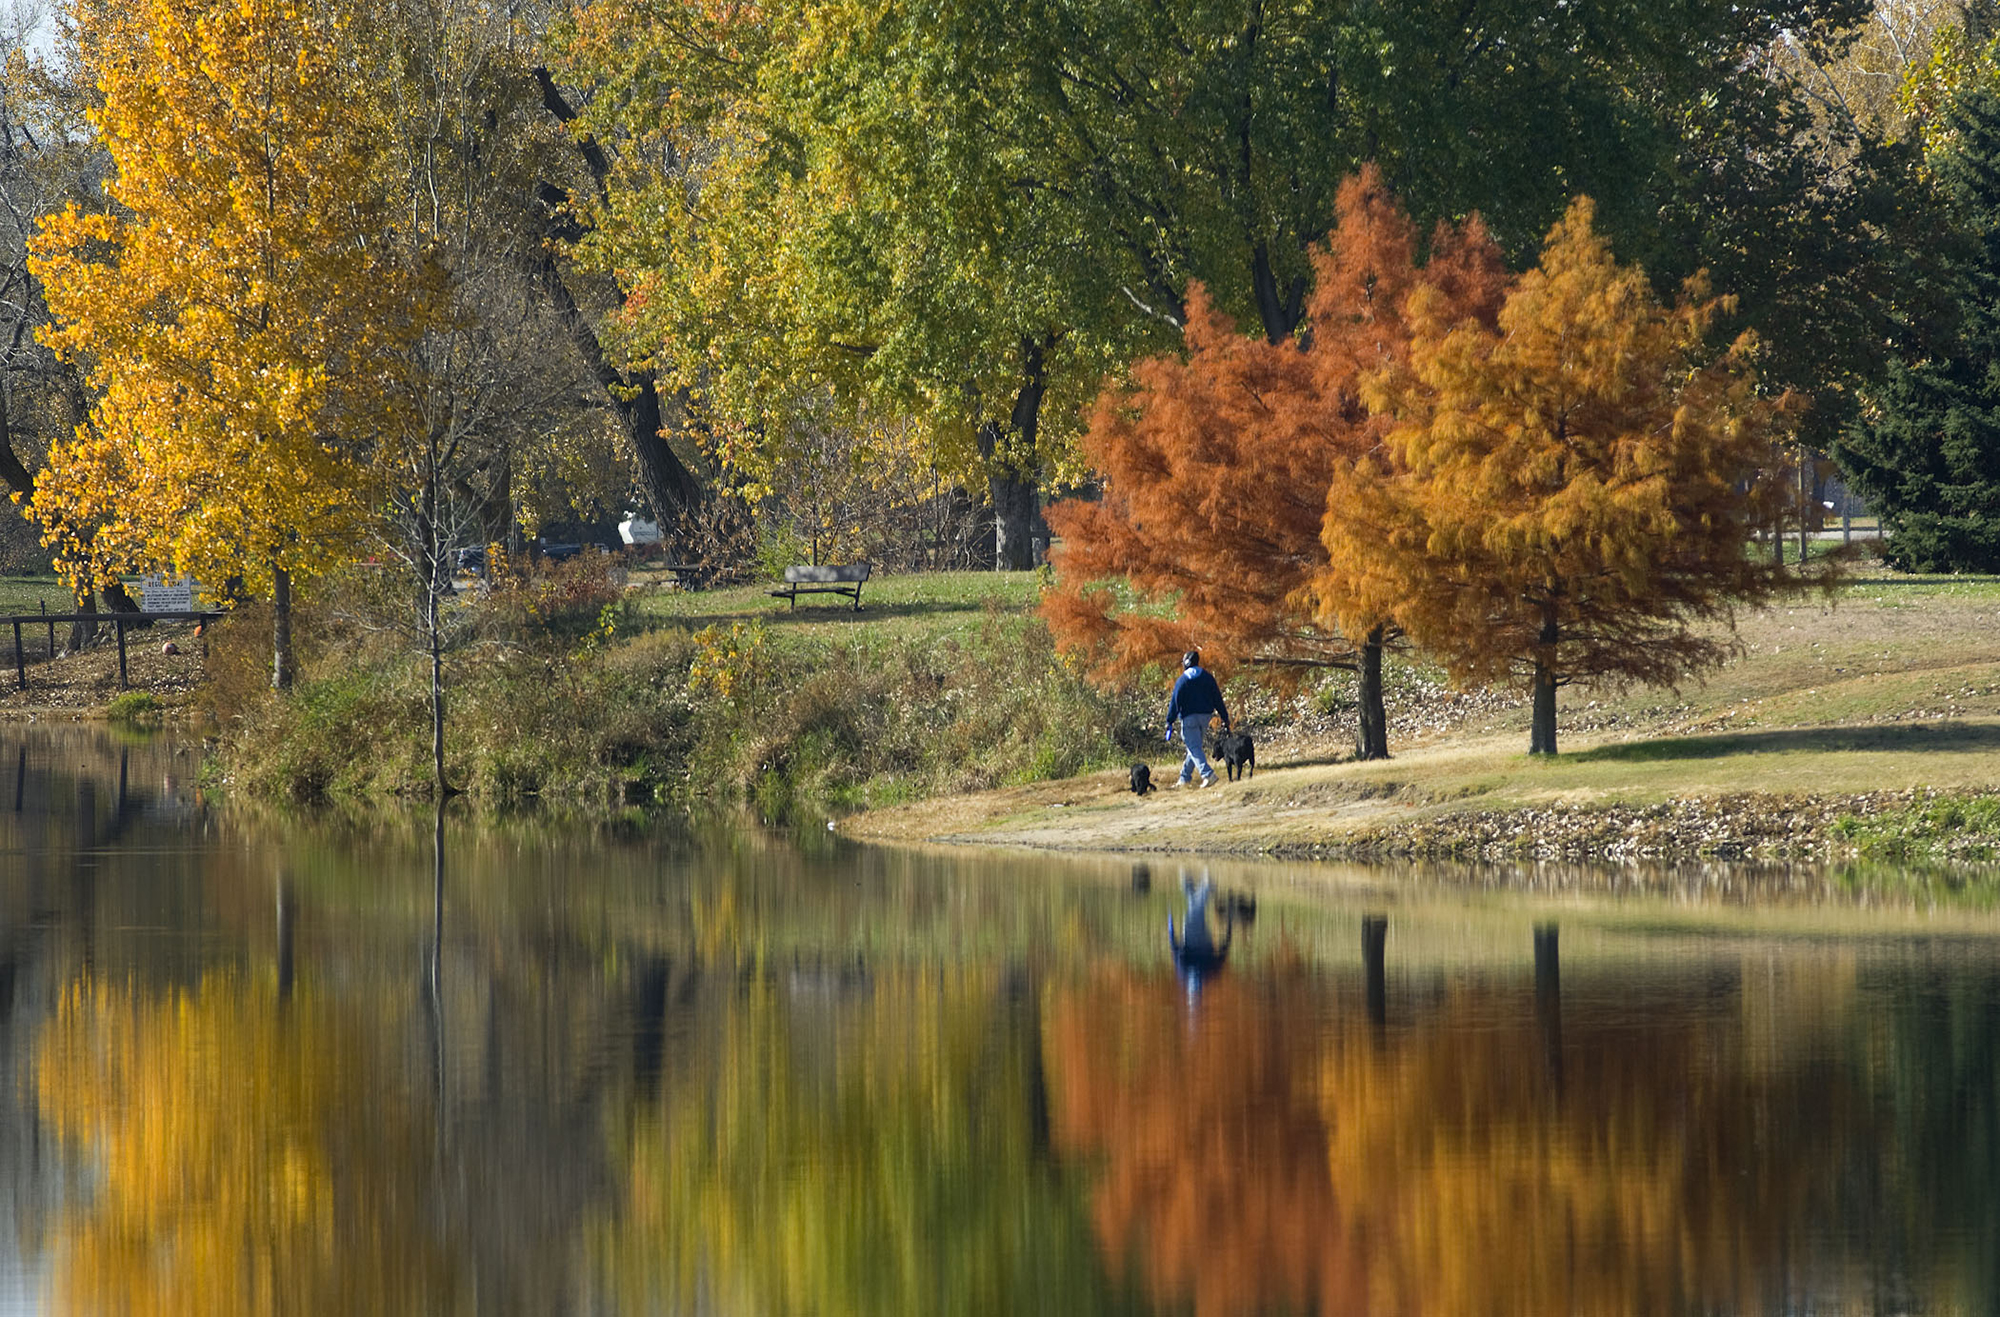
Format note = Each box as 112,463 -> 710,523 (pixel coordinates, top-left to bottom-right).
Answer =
846,580 -> 2000,849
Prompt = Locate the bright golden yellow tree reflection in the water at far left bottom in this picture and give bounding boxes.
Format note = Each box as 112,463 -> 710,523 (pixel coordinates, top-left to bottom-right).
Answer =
38,973 -> 452,1317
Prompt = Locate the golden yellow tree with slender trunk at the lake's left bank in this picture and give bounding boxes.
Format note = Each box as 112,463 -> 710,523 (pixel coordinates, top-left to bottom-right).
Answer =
30,0 -> 424,689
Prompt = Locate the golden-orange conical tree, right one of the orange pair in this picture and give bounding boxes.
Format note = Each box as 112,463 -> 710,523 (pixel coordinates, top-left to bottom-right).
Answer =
1312,198 -> 1792,755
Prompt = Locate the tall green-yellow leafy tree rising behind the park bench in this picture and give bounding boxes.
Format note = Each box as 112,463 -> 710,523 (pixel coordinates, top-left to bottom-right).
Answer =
566,0 -> 1158,568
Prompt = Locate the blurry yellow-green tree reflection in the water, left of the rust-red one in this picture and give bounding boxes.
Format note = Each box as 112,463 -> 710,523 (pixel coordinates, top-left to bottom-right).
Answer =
592,967 -> 1144,1315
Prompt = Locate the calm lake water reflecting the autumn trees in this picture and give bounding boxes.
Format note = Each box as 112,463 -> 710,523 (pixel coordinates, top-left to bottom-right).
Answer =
0,729 -> 2000,1315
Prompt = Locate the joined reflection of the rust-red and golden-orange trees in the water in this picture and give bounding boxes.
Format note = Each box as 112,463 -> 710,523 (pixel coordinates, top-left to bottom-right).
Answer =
1046,952 -> 1874,1317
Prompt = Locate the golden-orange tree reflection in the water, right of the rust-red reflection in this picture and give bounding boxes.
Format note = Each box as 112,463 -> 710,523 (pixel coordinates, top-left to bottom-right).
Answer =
1322,985 -> 1856,1317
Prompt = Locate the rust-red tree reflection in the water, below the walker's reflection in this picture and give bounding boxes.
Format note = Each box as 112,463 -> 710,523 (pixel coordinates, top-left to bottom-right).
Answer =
1046,952 -> 1368,1317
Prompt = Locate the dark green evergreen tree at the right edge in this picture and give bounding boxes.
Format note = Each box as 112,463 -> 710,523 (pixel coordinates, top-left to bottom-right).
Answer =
1834,80 -> 2000,572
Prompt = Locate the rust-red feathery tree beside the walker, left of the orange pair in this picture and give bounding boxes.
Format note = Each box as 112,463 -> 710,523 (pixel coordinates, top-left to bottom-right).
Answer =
1044,166 -> 1504,759
